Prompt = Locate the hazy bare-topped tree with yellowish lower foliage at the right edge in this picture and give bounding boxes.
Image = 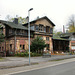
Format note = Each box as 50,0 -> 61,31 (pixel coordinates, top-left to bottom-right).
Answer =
67,15 -> 75,32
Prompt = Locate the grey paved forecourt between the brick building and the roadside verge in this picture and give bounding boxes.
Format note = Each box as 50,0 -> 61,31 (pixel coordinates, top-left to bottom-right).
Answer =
0,55 -> 75,69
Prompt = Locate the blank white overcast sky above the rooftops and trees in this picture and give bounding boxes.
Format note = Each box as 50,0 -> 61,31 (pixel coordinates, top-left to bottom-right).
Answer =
0,0 -> 75,31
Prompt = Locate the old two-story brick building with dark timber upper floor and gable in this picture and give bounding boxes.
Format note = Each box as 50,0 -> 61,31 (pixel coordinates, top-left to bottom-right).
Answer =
0,16 -> 55,55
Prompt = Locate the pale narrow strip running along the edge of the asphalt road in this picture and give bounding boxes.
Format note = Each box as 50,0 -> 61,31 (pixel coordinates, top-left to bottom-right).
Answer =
4,58 -> 75,75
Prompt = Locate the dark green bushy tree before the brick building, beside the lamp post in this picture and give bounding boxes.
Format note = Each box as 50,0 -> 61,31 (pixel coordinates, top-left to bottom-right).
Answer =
31,37 -> 46,52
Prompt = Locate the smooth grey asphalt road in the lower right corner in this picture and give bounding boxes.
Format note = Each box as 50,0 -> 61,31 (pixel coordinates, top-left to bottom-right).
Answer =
12,61 -> 75,75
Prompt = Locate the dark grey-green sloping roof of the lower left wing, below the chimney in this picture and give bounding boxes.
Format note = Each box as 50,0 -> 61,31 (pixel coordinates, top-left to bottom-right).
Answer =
0,20 -> 28,30
